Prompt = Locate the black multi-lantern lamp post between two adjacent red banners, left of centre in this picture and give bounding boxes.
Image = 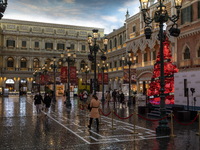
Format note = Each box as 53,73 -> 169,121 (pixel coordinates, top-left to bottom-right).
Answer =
61,47 -> 76,107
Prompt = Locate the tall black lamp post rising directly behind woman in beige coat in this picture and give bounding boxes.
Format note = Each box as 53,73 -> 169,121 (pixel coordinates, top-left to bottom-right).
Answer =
88,29 -> 108,95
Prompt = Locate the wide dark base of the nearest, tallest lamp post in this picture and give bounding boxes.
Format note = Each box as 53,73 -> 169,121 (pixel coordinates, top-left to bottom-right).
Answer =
156,119 -> 171,136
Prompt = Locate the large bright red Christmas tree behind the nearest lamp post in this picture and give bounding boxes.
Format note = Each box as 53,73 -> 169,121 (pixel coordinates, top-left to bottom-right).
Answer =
147,37 -> 178,105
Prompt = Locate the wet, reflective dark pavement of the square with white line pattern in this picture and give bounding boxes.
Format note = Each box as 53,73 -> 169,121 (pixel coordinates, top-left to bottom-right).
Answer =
0,96 -> 200,150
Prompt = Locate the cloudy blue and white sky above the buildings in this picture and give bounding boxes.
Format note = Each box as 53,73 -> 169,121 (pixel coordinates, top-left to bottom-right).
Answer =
3,0 -> 139,34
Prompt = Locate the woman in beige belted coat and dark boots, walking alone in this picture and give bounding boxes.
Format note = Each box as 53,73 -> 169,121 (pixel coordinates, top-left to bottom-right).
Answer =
88,95 -> 101,131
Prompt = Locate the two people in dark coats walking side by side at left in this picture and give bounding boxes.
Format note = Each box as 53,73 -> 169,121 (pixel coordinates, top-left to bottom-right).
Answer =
34,92 -> 51,115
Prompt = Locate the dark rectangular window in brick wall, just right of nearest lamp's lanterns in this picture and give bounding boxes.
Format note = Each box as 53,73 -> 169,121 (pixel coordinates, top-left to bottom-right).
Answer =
181,5 -> 193,24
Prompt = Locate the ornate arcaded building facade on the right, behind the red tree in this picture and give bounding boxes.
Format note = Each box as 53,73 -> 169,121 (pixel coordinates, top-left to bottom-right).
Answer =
107,0 -> 200,94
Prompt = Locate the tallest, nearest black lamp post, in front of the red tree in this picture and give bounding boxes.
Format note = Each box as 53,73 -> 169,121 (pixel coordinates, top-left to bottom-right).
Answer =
140,0 -> 182,135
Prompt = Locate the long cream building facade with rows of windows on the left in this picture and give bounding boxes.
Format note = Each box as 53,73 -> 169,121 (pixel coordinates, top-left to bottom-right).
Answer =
0,19 -> 104,93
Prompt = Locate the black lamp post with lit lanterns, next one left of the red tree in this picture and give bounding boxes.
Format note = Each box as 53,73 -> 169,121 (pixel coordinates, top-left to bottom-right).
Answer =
122,51 -> 136,105
